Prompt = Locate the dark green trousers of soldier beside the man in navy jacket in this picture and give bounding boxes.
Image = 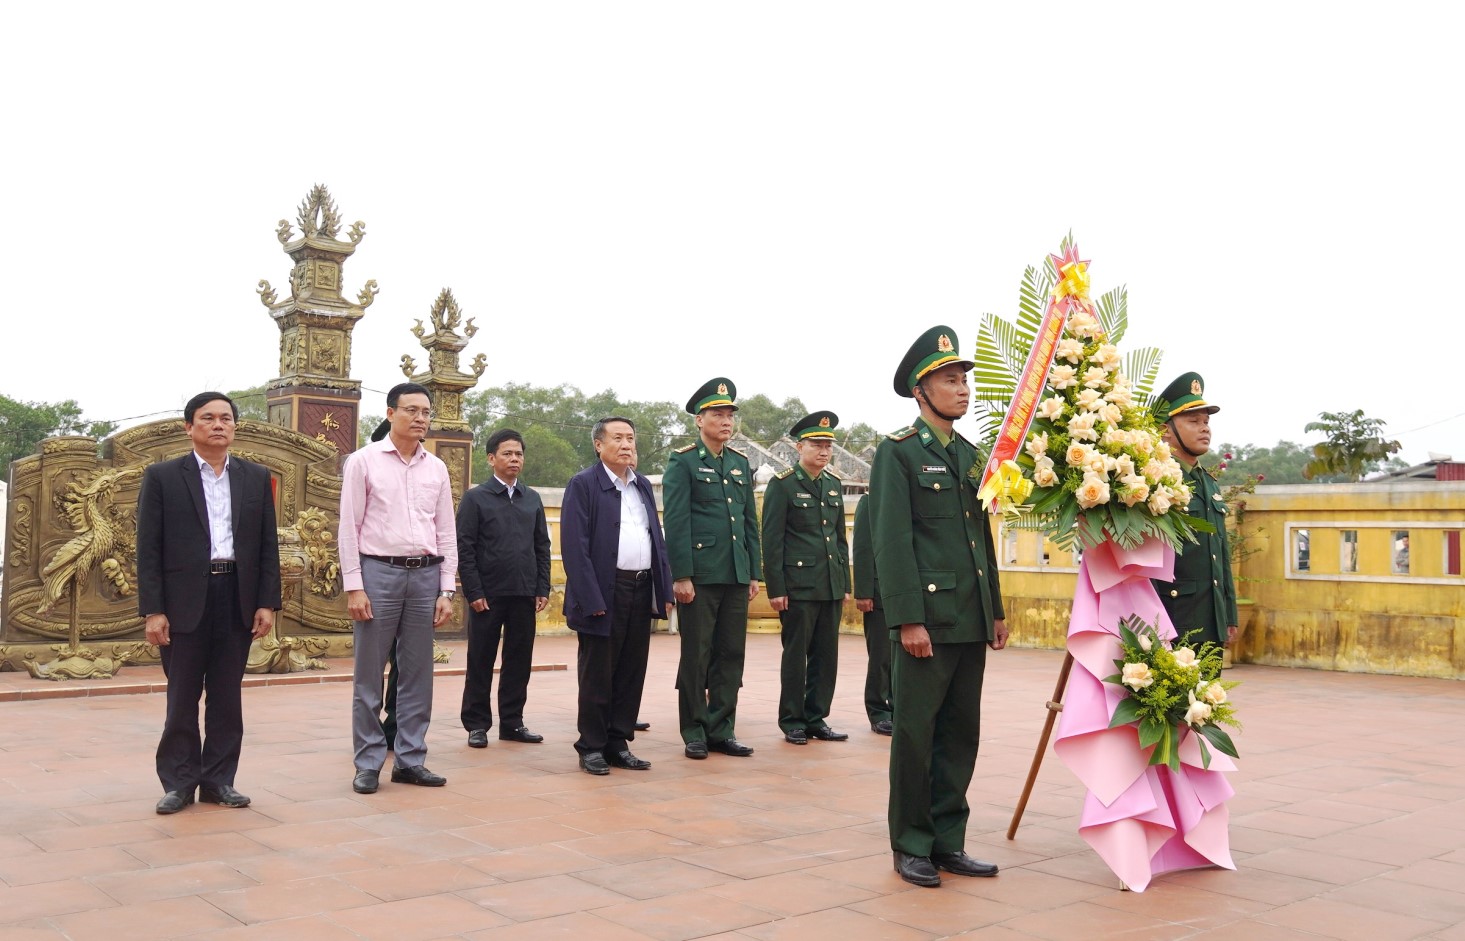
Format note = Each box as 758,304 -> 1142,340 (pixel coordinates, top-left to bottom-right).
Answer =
677,582 -> 747,742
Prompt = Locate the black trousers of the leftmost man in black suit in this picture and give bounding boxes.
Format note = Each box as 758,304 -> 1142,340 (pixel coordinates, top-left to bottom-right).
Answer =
157,575 -> 253,794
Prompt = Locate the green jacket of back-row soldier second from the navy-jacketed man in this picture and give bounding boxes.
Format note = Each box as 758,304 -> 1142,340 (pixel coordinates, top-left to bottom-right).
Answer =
763,465 -> 850,601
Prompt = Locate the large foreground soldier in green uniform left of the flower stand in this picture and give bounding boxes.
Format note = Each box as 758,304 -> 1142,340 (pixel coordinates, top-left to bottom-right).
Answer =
869,327 -> 1008,885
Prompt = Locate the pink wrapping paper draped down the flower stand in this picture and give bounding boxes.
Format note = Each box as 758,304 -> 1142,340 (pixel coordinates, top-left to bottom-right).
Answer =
1053,539 -> 1236,891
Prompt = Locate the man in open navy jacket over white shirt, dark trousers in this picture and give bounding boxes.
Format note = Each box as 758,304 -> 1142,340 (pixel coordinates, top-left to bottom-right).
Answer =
560,416 -> 671,774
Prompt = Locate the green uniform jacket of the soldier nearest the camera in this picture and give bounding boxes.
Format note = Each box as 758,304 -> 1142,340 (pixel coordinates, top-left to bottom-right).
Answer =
866,419 -> 1005,643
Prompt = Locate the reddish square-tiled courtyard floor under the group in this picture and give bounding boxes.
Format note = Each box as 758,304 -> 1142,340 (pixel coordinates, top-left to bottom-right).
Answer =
0,635 -> 1465,941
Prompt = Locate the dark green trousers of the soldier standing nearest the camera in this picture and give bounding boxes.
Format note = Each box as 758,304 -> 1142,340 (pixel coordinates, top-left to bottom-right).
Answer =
889,641 -> 987,856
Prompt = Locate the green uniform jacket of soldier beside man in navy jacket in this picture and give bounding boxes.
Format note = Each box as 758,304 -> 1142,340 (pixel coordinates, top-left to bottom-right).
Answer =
661,441 -> 762,585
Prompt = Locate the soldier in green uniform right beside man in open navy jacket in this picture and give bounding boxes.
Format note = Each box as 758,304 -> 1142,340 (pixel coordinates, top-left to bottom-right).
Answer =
662,378 -> 762,758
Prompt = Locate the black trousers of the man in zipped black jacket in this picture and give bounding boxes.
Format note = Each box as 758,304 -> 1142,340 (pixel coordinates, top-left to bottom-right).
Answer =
459,595 -> 535,731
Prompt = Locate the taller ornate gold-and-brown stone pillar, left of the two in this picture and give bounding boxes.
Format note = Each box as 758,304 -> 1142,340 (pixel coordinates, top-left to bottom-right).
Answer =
258,186 -> 377,457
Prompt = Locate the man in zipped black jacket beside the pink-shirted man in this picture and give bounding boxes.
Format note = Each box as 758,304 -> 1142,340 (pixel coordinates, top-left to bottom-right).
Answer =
457,428 -> 549,748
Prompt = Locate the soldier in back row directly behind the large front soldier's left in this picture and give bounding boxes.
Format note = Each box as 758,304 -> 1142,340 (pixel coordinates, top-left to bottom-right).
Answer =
763,412 -> 850,745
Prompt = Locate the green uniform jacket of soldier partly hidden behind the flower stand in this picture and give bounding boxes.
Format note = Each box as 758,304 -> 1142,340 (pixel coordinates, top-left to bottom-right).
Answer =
1154,465 -> 1236,643
